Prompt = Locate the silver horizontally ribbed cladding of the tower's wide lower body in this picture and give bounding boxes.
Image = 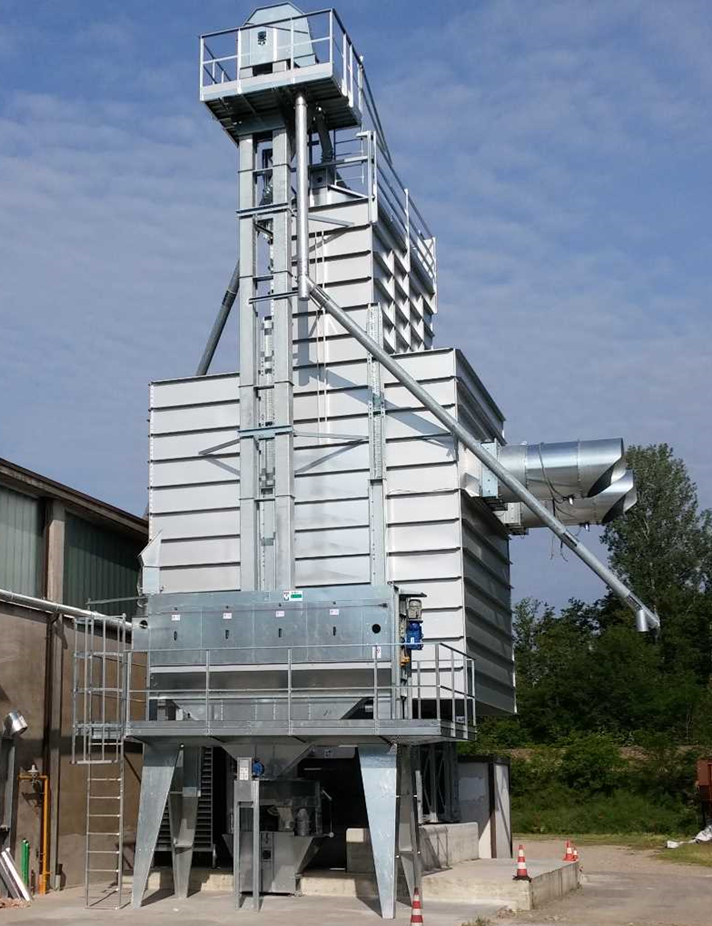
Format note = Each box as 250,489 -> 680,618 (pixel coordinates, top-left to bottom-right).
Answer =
150,348 -> 513,710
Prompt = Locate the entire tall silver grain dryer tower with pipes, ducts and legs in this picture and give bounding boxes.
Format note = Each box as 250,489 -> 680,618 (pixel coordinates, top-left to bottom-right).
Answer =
72,3 -> 657,918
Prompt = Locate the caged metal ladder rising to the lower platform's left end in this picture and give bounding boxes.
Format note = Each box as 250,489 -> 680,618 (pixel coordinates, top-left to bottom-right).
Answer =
72,614 -> 128,909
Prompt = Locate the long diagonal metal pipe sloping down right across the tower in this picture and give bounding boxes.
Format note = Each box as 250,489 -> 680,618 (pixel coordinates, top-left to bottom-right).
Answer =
309,280 -> 660,631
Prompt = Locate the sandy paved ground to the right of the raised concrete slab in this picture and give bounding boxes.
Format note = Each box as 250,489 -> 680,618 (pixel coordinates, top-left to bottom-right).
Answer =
510,840 -> 712,926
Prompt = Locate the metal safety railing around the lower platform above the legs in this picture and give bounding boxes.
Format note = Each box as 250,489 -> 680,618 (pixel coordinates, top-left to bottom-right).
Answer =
126,641 -> 476,739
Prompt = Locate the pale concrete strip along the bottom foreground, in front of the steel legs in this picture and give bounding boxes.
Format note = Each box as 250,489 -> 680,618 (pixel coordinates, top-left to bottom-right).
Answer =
2,888 -> 506,926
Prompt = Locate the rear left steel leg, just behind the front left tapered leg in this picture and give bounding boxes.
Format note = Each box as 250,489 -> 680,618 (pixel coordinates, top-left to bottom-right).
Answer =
168,746 -> 202,900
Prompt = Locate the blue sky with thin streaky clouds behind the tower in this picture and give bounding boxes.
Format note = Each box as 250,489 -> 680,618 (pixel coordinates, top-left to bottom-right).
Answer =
0,0 -> 712,603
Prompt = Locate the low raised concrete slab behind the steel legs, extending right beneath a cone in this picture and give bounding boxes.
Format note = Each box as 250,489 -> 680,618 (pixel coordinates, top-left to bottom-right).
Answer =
131,859 -> 580,911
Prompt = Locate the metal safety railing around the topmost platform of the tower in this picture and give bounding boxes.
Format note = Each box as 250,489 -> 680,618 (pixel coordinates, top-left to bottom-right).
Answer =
200,10 -> 364,111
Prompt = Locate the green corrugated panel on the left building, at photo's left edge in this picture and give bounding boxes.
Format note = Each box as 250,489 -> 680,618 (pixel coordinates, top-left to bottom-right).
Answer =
0,486 -> 43,595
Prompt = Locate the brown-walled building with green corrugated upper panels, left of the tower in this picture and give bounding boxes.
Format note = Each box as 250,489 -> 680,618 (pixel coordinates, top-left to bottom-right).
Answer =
0,459 -> 147,889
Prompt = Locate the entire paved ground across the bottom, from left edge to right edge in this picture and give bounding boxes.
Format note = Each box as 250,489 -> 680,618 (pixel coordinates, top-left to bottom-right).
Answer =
5,840 -> 712,926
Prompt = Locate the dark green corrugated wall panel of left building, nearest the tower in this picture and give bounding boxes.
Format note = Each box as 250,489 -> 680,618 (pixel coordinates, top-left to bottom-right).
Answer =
64,515 -> 142,614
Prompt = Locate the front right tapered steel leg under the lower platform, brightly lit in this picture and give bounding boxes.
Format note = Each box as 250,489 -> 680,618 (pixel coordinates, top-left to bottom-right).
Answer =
358,746 -> 398,920
